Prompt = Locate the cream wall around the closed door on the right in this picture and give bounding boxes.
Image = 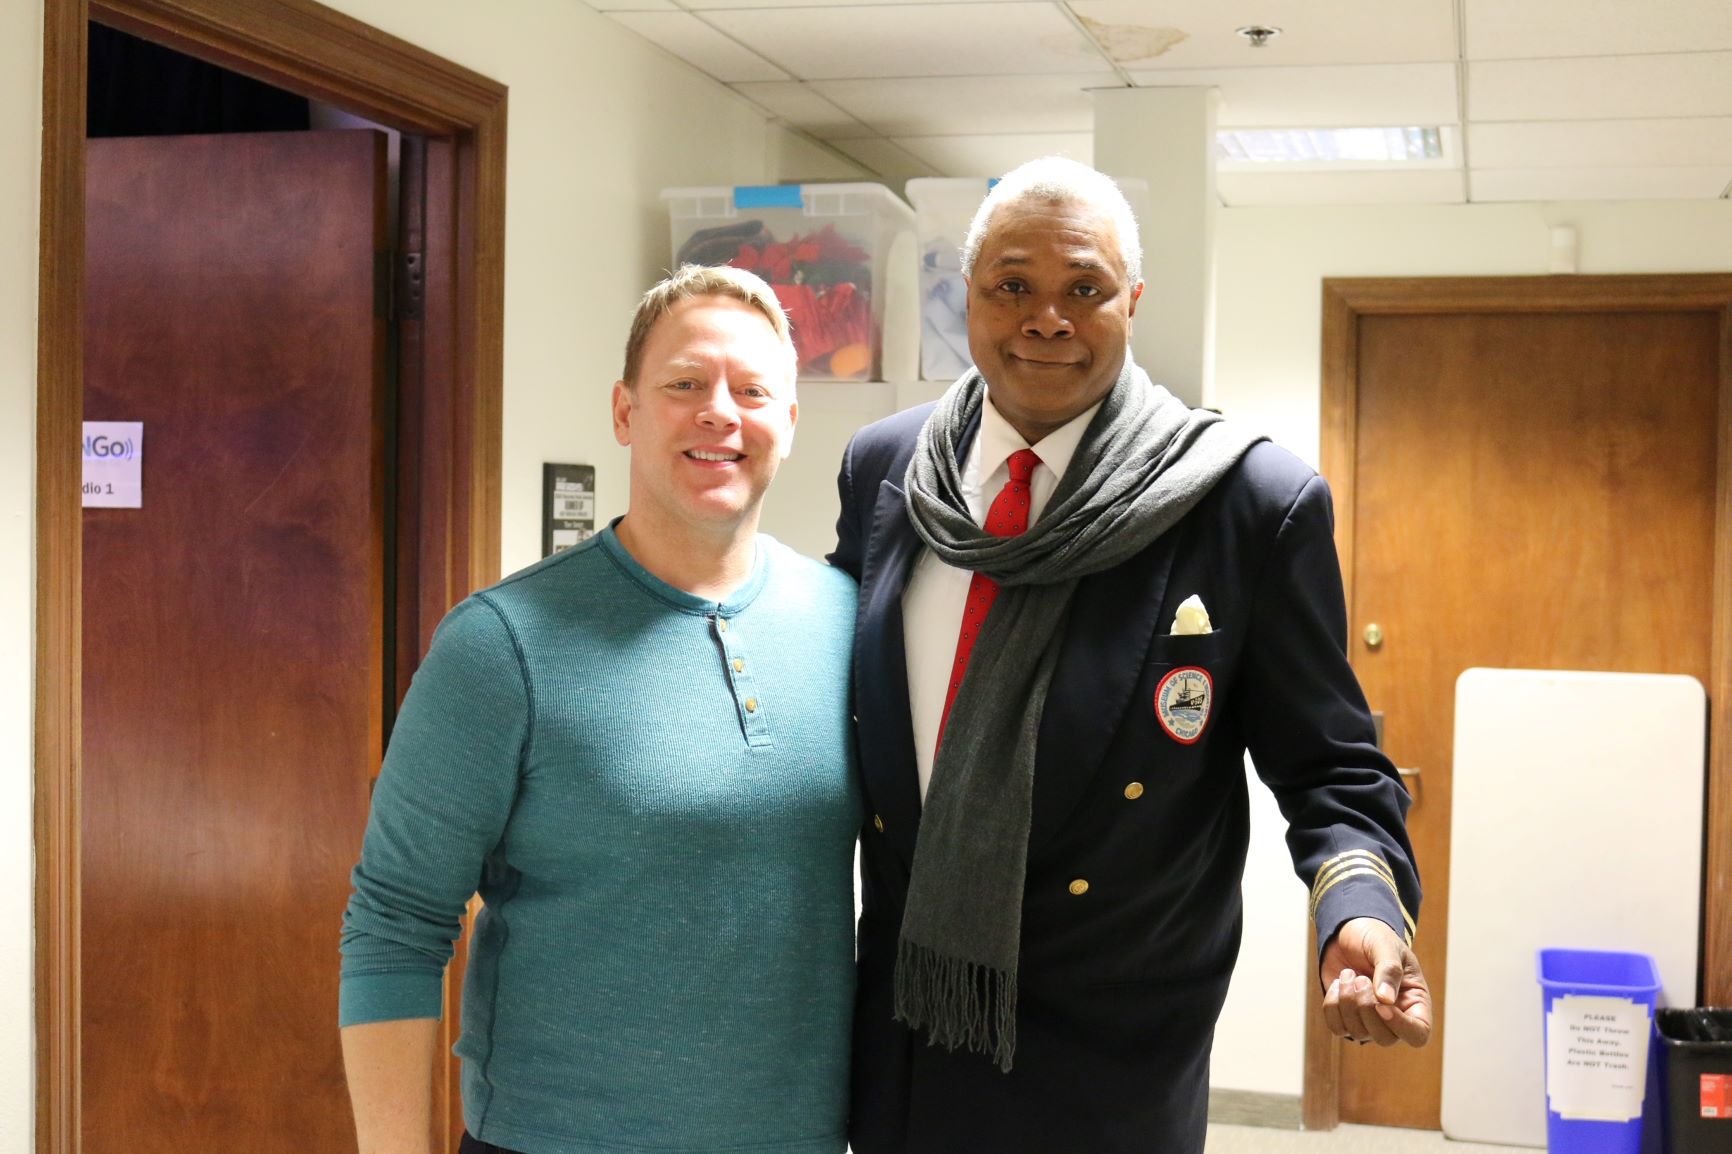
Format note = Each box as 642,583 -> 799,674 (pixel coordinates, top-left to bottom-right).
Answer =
1212,193 -> 1732,1093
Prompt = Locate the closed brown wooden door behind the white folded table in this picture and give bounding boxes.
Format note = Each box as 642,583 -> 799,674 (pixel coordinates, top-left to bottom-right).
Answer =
1316,289 -> 1723,1130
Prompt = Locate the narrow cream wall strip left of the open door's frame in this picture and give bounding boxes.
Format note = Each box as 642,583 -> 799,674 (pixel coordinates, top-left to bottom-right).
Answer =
0,0 -> 42,1154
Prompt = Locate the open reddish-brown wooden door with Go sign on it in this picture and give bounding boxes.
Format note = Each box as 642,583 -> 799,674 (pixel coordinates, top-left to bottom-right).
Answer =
81,132 -> 386,1154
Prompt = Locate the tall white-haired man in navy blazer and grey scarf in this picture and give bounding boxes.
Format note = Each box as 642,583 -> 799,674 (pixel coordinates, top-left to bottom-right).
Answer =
831,161 -> 1431,1154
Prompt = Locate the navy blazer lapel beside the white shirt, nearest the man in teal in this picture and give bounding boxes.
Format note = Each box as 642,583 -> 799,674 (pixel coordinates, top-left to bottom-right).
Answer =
854,480 -> 921,866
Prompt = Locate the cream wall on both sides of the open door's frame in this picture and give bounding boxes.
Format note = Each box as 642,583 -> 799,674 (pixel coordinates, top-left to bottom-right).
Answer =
0,0 -> 859,1154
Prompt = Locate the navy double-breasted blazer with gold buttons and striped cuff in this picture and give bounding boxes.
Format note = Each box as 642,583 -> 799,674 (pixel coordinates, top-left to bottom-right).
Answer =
830,405 -> 1420,1154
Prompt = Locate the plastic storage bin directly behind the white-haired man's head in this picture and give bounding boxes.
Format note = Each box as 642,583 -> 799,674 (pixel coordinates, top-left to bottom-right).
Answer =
906,177 -> 1148,381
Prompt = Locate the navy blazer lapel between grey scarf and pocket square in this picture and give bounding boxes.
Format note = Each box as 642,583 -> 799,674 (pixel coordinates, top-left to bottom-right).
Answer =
1029,534 -> 1179,854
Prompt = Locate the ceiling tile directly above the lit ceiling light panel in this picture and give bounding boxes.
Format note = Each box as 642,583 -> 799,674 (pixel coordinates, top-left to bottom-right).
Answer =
1129,64 -> 1460,128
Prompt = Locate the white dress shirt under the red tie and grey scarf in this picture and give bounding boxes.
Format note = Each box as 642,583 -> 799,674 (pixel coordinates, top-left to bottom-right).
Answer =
902,392 -> 1100,801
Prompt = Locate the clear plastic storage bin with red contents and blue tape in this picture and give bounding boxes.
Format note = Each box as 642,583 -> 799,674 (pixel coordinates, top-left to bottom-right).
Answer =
662,184 -> 914,381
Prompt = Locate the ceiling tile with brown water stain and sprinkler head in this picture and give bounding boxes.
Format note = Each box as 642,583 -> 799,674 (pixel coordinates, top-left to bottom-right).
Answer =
1070,0 -> 1457,69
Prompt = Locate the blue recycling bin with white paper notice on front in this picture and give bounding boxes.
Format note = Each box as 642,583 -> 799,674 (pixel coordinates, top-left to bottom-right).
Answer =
1538,950 -> 1659,1154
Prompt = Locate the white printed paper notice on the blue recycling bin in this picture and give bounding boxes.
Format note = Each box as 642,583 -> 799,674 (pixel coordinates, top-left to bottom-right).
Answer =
1545,995 -> 1652,1121
